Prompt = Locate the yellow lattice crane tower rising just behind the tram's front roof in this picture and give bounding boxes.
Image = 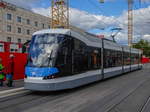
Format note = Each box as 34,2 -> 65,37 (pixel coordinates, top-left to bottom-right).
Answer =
51,0 -> 69,29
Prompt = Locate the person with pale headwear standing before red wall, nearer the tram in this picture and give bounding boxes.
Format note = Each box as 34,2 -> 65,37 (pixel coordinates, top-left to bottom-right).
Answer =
6,54 -> 14,87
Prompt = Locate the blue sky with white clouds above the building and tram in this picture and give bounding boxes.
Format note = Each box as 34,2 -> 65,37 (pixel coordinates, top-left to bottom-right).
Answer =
4,0 -> 150,44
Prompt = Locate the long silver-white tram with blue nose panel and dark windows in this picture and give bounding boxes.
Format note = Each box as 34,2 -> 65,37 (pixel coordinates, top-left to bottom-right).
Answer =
25,29 -> 142,91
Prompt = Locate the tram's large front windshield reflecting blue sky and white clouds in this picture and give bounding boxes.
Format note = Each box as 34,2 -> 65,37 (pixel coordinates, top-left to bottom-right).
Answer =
27,34 -> 64,67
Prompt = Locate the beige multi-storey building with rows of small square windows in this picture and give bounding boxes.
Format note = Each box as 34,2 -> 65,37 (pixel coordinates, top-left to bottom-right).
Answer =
0,0 -> 50,43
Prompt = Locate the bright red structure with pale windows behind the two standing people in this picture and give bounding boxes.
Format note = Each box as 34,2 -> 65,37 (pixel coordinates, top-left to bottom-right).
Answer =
0,41 -> 27,80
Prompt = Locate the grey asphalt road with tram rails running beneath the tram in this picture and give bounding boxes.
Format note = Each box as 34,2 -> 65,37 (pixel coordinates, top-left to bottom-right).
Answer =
0,64 -> 150,112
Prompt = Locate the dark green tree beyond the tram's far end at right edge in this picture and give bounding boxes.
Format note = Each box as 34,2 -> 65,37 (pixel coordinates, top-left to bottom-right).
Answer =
133,39 -> 150,57
